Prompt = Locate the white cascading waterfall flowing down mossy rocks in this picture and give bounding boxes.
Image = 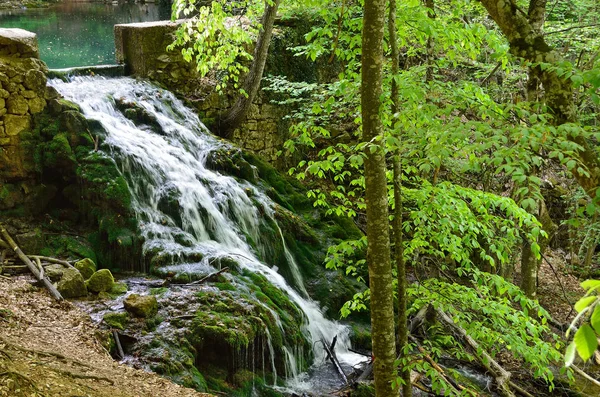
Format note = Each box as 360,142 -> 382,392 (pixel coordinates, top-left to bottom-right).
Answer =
51,77 -> 361,388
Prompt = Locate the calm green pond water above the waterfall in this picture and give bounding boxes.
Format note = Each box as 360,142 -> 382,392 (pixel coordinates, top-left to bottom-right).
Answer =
0,0 -> 171,69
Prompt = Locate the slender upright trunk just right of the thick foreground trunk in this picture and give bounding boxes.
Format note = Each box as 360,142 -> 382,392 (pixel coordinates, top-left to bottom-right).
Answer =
388,0 -> 412,397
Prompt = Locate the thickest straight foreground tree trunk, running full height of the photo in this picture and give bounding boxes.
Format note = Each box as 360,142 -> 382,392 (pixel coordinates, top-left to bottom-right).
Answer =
361,0 -> 398,397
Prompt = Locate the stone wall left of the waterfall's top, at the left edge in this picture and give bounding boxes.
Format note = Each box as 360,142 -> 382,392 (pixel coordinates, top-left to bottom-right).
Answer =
0,29 -> 51,185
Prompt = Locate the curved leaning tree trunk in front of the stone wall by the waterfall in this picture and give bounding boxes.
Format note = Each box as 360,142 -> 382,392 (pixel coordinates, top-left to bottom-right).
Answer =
212,0 -> 281,139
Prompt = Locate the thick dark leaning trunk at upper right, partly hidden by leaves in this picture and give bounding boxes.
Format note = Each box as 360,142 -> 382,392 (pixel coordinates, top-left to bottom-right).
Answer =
481,0 -> 600,197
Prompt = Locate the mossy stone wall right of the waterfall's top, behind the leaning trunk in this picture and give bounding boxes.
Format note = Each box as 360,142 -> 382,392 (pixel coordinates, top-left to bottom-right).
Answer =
115,21 -> 317,163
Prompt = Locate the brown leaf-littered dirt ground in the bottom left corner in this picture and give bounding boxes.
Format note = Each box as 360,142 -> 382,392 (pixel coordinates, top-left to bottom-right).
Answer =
0,277 -> 210,397
